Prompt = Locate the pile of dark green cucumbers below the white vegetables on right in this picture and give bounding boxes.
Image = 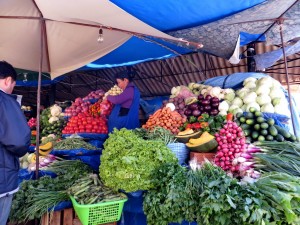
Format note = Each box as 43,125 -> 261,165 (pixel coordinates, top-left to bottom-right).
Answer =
236,107 -> 297,142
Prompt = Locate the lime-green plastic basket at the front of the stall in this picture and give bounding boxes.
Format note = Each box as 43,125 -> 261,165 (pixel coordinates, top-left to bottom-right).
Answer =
70,196 -> 127,225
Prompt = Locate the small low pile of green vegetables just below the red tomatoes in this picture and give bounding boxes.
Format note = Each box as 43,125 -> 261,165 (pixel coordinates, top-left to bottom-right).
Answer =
54,138 -> 97,150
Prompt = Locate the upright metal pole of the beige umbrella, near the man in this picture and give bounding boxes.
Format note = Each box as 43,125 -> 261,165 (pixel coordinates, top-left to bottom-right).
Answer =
35,18 -> 44,179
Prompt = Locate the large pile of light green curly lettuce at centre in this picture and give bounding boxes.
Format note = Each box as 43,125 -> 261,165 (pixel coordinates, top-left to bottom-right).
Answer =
100,128 -> 178,192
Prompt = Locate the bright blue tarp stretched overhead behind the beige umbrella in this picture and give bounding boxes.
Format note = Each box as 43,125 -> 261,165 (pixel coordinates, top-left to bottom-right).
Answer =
81,0 -> 265,70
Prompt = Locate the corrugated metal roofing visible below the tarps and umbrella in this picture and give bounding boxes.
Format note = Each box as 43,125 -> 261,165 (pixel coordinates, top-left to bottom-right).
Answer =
15,43 -> 300,104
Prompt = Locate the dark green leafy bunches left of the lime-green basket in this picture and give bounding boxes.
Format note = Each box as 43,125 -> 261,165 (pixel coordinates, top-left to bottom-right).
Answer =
9,160 -> 91,223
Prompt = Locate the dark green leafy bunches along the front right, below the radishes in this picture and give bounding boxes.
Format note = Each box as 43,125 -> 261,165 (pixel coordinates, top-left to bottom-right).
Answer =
144,163 -> 300,225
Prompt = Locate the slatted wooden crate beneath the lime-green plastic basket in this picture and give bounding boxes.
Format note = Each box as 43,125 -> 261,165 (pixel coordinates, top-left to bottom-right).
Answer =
41,208 -> 117,225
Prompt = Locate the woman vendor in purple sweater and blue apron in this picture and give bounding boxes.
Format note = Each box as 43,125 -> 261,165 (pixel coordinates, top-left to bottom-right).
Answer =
107,71 -> 140,132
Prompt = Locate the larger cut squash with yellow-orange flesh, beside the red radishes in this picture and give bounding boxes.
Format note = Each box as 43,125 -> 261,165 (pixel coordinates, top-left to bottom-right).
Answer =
186,131 -> 218,152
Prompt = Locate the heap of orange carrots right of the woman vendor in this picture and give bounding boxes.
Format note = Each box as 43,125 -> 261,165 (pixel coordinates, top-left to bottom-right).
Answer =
142,107 -> 186,134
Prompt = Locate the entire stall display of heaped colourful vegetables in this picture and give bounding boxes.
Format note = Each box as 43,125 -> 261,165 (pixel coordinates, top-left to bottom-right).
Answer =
10,72 -> 300,225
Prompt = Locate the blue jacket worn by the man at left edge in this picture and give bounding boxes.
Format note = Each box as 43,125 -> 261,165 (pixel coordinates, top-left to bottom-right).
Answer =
0,91 -> 31,194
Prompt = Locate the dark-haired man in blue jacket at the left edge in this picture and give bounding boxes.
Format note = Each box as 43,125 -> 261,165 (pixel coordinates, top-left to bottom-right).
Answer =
0,61 -> 30,225
